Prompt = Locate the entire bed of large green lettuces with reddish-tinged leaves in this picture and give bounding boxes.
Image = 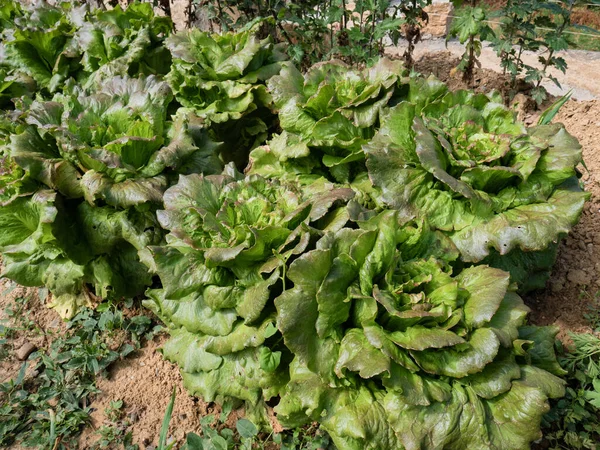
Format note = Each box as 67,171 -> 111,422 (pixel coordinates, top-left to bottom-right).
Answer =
0,3 -> 588,449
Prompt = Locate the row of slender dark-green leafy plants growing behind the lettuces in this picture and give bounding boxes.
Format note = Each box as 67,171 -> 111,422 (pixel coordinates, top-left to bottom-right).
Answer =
188,0 -> 600,104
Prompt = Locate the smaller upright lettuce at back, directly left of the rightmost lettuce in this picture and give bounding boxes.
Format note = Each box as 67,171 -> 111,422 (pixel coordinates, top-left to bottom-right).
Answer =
266,58 -> 407,182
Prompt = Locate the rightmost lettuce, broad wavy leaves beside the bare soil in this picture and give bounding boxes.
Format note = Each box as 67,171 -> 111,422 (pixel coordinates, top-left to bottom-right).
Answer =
364,80 -> 589,290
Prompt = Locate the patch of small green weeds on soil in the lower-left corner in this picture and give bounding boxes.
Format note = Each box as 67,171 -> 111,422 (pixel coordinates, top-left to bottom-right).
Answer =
0,300 -> 158,450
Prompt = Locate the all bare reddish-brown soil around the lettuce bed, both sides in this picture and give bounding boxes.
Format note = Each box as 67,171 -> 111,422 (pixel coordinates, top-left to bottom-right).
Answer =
0,53 -> 600,450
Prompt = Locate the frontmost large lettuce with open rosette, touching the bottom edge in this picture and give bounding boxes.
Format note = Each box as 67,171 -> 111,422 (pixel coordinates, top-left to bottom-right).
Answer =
275,211 -> 564,449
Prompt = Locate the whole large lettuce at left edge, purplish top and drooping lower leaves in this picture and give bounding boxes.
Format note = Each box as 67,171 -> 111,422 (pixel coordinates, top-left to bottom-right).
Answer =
0,76 -> 222,316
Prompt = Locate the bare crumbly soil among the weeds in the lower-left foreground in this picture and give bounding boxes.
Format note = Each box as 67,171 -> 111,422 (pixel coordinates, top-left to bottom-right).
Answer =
0,280 -> 209,450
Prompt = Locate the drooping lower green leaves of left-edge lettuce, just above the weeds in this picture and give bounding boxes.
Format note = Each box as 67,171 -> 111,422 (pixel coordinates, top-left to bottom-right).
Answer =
0,188 -> 162,318
